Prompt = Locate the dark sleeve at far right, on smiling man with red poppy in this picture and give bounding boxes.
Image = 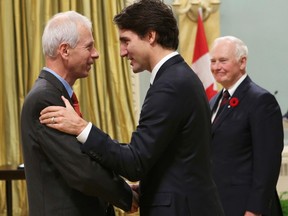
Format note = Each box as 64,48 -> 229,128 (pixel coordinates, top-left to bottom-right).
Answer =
247,93 -> 283,213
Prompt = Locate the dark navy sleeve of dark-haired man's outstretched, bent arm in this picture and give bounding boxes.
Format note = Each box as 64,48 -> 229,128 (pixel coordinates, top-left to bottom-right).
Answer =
82,78 -> 192,181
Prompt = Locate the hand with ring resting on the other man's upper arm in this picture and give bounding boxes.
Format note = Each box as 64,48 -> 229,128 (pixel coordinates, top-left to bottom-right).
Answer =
39,96 -> 88,136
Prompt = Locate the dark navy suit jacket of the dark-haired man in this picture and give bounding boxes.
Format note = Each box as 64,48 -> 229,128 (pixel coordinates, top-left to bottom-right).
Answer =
82,55 -> 223,216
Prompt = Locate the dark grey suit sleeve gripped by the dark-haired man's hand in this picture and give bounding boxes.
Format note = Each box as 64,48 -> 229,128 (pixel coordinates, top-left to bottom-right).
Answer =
34,89 -> 132,211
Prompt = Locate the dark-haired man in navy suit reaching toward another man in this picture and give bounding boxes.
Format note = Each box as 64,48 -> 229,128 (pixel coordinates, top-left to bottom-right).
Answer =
40,0 -> 223,216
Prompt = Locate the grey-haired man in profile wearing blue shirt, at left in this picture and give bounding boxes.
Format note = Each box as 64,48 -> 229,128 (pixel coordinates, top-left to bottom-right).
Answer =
21,11 -> 135,216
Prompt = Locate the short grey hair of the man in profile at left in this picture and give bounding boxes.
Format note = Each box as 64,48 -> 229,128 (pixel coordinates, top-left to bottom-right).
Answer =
42,11 -> 92,57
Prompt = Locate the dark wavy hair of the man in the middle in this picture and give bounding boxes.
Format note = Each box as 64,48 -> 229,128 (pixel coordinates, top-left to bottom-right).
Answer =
113,0 -> 179,50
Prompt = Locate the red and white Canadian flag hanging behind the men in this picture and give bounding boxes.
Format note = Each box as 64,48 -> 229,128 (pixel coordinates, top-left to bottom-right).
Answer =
192,10 -> 217,100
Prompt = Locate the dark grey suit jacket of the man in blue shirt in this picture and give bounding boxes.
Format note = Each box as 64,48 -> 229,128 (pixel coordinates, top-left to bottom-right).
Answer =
21,71 -> 132,216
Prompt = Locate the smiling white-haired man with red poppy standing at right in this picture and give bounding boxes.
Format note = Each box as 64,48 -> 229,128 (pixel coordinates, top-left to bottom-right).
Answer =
210,36 -> 283,216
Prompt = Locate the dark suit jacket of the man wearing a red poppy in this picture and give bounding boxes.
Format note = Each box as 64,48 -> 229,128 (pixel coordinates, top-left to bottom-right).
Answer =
210,77 -> 283,216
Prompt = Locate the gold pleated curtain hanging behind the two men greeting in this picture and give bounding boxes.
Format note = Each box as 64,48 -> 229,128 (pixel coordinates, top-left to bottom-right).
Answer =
0,0 -> 137,216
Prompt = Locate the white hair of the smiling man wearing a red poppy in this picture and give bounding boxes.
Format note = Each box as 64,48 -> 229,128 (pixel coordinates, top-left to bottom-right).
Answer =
213,36 -> 248,60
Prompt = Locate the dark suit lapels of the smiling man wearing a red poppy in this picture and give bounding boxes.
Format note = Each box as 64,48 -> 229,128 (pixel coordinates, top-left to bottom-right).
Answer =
211,76 -> 251,133
